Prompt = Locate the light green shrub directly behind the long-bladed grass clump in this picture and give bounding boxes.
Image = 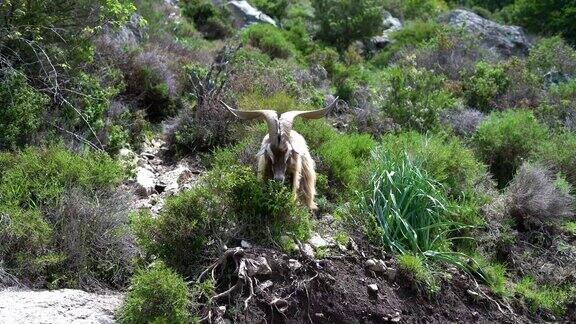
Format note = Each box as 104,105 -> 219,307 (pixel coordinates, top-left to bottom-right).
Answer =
382,132 -> 487,198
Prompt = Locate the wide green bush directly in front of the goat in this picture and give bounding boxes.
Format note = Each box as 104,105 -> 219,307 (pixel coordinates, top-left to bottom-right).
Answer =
141,165 -> 311,275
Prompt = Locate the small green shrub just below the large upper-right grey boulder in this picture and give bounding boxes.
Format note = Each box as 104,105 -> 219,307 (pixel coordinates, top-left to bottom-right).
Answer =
464,62 -> 510,112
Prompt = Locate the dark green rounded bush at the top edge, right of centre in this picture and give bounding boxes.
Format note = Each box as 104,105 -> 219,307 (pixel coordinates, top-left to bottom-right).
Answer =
312,0 -> 383,50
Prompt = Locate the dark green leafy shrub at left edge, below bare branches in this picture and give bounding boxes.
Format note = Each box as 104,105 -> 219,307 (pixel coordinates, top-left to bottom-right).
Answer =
0,71 -> 48,149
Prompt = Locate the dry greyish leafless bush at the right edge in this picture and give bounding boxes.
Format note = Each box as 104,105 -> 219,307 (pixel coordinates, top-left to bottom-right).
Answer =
506,163 -> 574,229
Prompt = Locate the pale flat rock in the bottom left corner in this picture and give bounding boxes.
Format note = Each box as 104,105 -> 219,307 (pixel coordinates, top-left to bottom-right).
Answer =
0,289 -> 122,323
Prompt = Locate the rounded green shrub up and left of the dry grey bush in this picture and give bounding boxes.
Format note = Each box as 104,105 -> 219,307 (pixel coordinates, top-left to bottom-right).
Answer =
472,110 -> 548,188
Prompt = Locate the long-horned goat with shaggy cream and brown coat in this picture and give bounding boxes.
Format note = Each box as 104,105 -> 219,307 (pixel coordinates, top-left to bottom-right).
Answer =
221,100 -> 336,211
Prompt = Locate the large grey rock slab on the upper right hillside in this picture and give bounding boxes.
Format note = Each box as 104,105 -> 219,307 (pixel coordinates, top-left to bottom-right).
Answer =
439,9 -> 530,57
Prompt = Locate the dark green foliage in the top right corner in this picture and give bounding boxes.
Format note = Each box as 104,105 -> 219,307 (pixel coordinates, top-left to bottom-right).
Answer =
511,0 -> 576,44
